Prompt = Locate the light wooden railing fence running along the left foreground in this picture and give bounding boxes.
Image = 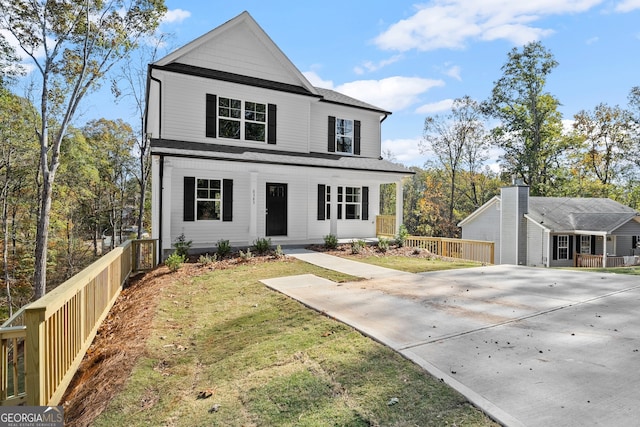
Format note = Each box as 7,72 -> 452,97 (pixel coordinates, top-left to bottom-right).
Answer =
0,240 -> 157,406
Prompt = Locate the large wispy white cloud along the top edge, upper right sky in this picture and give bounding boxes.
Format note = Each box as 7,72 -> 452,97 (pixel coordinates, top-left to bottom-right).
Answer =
374,0 -> 604,52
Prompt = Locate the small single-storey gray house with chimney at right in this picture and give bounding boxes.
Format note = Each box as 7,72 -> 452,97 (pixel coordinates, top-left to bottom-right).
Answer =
458,185 -> 640,267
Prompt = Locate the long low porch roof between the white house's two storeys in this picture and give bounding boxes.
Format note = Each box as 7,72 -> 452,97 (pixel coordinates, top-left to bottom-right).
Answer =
151,139 -> 415,175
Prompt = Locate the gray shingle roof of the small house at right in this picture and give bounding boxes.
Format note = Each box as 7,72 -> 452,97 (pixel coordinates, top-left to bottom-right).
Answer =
527,197 -> 638,232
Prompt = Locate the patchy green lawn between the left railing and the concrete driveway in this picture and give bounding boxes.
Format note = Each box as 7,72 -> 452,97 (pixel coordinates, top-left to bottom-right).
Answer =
94,261 -> 497,426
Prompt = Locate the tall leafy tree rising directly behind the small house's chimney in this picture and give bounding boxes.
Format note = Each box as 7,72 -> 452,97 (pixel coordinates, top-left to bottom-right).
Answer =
483,42 -> 567,196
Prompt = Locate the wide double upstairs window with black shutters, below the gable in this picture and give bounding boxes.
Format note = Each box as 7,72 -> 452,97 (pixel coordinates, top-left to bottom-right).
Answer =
206,94 -> 276,144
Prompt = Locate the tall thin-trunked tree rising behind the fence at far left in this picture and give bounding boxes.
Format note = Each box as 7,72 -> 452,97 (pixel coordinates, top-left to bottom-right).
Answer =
0,0 -> 166,298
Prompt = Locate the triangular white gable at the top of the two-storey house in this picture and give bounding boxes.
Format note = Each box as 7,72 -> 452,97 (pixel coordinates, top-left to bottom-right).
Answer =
153,11 -> 318,95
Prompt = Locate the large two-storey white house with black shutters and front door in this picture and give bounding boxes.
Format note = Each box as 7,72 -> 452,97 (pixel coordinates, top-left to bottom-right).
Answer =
145,12 -> 413,257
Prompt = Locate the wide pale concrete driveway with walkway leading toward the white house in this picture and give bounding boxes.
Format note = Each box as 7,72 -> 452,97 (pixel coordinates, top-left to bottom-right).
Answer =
263,251 -> 640,426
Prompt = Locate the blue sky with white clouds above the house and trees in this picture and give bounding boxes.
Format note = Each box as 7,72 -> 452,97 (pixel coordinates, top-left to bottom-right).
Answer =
8,0 -> 640,166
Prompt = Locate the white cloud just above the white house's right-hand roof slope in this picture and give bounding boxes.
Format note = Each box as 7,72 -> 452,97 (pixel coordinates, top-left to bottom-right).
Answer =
335,76 -> 444,112
